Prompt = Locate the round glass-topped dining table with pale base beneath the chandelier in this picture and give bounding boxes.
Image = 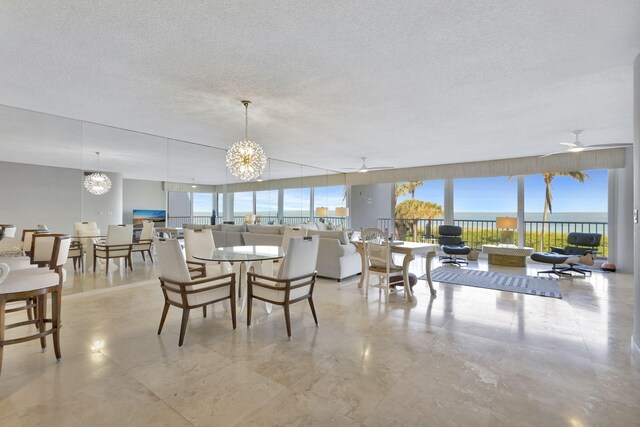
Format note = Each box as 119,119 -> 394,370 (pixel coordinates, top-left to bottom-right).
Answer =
194,246 -> 284,314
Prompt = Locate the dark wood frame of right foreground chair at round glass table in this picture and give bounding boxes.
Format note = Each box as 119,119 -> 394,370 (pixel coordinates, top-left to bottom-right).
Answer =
247,272 -> 318,340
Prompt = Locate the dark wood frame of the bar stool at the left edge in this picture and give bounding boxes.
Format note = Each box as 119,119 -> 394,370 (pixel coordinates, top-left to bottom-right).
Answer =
0,236 -> 71,373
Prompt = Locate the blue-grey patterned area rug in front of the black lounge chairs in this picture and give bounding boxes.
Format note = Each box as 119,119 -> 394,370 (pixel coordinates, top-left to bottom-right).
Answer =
420,267 -> 562,299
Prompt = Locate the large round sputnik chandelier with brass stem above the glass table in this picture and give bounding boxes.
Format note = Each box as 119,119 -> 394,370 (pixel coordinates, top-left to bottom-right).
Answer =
226,100 -> 267,181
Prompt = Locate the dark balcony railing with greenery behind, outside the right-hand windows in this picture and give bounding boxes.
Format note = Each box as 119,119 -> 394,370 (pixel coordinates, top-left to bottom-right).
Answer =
378,218 -> 609,257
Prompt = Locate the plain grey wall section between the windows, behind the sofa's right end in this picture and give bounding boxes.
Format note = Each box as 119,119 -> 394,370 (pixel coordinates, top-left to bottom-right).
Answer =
349,184 -> 393,232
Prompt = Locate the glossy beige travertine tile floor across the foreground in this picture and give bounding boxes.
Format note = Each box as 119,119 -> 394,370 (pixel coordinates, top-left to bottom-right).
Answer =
0,260 -> 640,427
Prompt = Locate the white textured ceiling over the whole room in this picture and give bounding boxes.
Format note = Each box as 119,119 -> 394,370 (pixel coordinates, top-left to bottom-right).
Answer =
0,0 -> 640,181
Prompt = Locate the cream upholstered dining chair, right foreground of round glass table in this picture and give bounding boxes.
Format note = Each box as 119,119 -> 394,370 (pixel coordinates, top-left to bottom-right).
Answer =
247,236 -> 320,340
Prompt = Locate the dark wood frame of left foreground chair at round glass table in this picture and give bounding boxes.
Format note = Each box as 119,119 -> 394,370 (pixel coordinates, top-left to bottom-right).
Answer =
158,273 -> 236,346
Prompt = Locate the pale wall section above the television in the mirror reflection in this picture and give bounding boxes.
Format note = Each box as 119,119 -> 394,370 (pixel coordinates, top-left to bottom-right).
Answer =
122,179 -> 167,224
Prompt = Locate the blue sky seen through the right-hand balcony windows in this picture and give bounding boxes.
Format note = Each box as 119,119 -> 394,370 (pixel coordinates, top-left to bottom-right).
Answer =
398,170 -> 608,212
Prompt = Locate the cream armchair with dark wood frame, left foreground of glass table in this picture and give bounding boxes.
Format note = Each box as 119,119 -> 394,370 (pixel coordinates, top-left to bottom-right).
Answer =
154,238 -> 236,346
